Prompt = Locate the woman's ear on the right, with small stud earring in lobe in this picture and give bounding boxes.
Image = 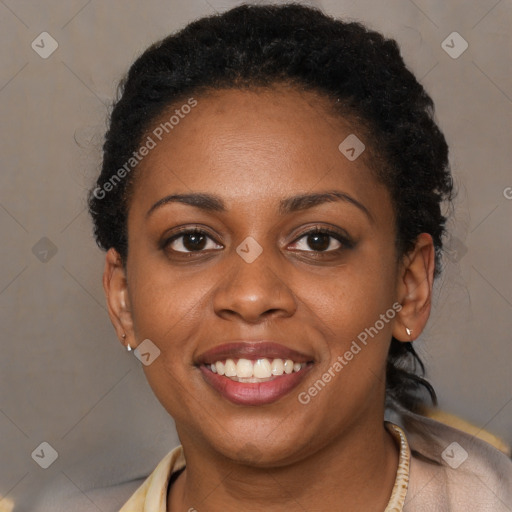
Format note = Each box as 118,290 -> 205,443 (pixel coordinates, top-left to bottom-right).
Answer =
393,233 -> 435,341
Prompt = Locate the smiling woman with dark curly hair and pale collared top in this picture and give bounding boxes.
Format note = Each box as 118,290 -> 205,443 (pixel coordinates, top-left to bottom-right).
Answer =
90,5 -> 512,512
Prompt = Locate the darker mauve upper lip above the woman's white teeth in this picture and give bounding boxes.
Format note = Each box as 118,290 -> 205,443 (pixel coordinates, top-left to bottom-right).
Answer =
196,341 -> 313,365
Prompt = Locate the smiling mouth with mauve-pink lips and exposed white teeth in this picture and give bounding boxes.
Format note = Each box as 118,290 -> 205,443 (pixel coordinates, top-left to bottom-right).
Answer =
197,342 -> 314,406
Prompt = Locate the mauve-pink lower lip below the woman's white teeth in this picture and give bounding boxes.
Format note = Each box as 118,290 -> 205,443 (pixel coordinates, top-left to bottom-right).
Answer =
199,365 -> 313,405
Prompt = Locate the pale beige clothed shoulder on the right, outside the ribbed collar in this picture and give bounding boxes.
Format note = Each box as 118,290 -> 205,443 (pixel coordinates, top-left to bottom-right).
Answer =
402,412 -> 512,512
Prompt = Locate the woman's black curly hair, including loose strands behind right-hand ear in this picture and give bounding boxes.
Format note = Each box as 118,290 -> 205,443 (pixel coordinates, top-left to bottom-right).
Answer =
89,4 -> 453,411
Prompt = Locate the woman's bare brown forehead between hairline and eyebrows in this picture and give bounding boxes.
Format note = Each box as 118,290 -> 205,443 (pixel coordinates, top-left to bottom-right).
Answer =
127,86 -> 385,215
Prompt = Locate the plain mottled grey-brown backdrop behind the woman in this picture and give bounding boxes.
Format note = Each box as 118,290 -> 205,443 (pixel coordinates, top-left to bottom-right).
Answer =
0,0 -> 512,511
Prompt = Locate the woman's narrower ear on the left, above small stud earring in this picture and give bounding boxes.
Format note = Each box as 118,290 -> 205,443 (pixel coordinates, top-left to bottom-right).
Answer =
103,248 -> 135,348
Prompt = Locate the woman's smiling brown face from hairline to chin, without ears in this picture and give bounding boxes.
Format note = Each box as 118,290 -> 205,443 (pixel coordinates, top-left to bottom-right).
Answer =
105,88 -> 424,465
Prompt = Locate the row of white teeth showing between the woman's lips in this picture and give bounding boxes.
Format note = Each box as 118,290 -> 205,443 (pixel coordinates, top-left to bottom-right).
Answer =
208,358 -> 307,382
